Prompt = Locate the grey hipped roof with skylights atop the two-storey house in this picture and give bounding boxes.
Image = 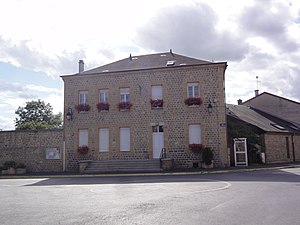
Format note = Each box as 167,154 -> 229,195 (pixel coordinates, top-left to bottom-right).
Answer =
80,51 -> 213,74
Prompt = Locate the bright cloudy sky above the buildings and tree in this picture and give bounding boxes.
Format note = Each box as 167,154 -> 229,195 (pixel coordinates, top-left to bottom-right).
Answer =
0,0 -> 300,130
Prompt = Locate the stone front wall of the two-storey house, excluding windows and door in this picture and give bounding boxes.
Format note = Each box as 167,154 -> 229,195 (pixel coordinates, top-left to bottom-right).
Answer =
62,59 -> 228,171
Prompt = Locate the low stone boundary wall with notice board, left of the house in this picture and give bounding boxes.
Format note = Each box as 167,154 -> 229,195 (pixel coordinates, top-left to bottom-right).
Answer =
0,129 -> 63,173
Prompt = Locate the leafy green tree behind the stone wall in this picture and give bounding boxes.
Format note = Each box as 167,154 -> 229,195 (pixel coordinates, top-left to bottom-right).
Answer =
15,99 -> 62,130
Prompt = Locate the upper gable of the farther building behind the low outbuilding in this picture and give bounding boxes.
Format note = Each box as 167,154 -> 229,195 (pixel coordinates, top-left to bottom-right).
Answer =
240,92 -> 300,123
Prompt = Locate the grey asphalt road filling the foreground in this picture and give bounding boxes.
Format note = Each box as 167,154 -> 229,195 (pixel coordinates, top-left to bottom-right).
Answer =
0,168 -> 300,225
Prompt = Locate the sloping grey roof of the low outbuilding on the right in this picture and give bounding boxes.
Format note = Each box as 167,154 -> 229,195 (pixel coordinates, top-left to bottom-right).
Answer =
226,104 -> 289,132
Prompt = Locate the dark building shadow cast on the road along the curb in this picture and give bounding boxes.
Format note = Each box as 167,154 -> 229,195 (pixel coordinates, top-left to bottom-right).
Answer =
26,168 -> 300,186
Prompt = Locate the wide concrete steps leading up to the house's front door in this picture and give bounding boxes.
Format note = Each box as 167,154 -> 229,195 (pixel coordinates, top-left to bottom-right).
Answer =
84,159 -> 161,174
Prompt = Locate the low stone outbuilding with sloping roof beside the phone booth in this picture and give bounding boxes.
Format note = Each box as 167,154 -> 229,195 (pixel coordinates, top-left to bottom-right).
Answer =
227,104 -> 300,165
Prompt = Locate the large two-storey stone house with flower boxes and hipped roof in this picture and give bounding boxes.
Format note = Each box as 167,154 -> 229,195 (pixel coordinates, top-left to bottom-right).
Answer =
62,51 -> 229,171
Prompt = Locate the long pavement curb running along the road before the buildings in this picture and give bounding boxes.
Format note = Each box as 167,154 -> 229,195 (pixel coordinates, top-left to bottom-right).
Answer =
0,164 -> 300,180
